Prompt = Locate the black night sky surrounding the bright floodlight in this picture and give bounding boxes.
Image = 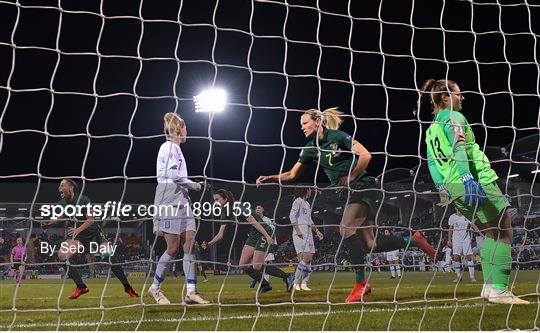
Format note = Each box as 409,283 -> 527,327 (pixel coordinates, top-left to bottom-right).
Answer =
0,0 -> 540,200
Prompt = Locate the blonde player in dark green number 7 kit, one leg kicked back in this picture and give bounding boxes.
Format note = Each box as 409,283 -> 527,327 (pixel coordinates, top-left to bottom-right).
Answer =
257,108 -> 436,303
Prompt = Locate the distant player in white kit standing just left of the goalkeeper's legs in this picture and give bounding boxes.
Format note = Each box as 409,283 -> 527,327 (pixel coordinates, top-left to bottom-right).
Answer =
448,209 -> 480,283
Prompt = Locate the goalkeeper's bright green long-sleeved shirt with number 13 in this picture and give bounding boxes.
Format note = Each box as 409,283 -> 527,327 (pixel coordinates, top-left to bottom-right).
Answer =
426,110 -> 498,186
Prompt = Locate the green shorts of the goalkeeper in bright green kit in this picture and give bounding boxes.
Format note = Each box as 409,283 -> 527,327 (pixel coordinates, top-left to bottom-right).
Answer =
447,181 -> 510,223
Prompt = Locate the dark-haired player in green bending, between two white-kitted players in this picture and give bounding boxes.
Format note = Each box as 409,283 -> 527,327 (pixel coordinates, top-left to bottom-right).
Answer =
201,189 -> 293,292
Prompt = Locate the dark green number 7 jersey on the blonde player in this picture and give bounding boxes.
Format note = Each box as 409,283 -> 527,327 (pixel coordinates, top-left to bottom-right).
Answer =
298,129 -> 365,185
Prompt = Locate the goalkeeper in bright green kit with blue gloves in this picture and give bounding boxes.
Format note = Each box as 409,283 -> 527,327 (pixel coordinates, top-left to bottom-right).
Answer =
422,79 -> 529,304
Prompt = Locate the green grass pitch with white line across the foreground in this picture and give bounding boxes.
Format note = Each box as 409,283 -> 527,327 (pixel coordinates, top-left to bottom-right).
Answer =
0,271 -> 540,331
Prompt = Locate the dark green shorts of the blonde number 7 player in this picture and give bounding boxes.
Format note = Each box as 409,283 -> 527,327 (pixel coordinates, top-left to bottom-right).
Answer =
338,175 -> 382,219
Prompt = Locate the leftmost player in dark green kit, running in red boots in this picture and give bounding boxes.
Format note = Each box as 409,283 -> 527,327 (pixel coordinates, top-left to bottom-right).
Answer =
42,178 -> 139,299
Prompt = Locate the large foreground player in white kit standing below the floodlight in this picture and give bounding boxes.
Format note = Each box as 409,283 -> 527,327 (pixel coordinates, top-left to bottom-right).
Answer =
148,112 -> 209,304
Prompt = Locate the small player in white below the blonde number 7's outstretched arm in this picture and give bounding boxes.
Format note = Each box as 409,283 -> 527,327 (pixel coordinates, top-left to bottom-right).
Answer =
289,187 -> 324,291
